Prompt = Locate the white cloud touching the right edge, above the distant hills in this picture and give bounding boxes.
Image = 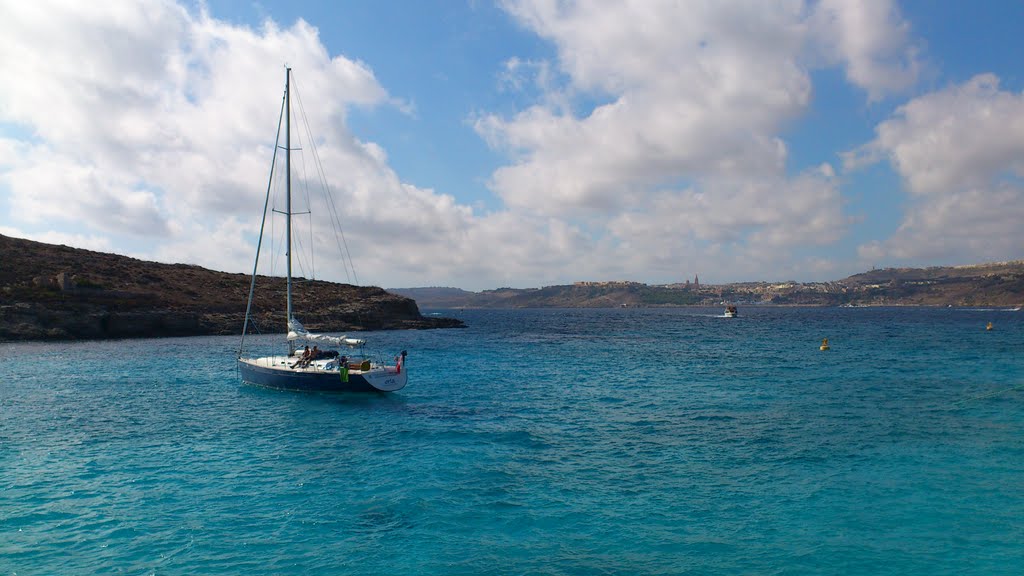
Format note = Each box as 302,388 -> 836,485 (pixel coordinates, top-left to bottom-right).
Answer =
847,74 -> 1024,261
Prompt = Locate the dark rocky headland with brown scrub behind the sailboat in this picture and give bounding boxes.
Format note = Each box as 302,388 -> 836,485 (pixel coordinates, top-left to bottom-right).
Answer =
0,236 -> 462,340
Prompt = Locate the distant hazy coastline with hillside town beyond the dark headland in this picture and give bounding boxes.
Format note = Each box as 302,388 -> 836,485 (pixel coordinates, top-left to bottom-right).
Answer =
392,260 -> 1024,308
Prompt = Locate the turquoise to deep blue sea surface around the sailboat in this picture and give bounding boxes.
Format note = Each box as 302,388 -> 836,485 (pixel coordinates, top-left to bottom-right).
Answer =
0,306 -> 1024,575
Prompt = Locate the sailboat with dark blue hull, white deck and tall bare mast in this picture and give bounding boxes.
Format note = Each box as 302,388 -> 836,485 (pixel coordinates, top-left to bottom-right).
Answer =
238,68 -> 409,393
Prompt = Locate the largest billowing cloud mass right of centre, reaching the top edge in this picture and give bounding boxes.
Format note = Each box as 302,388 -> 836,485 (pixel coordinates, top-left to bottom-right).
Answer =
475,0 -> 888,272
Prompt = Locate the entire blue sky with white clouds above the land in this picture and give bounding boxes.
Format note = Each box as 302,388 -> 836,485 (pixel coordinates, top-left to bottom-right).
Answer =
0,0 -> 1024,290
